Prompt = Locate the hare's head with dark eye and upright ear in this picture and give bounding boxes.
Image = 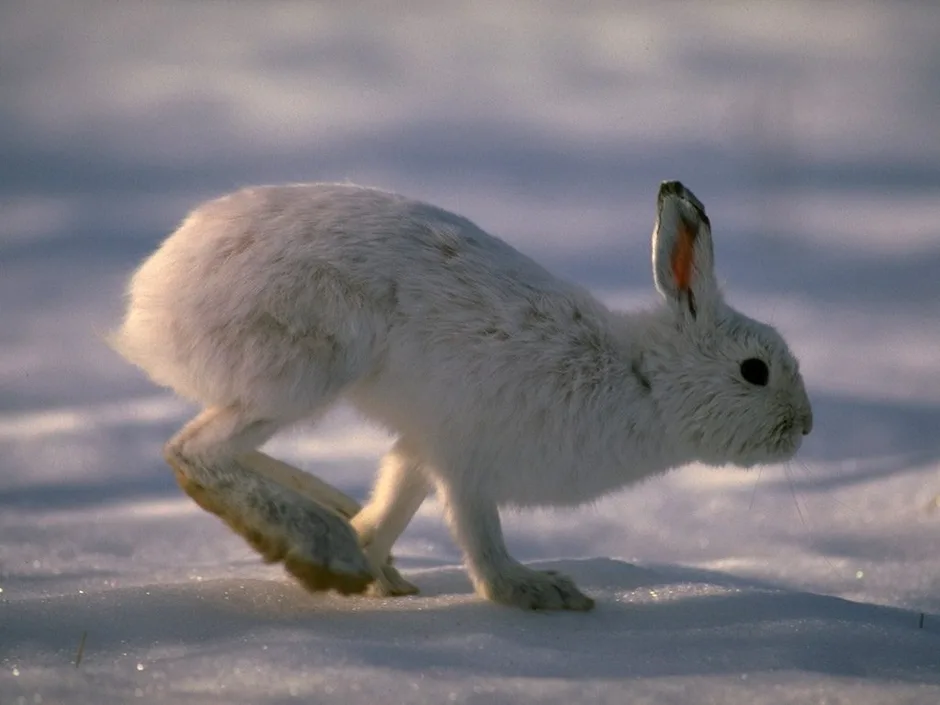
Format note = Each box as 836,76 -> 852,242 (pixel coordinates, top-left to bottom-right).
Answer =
649,181 -> 813,467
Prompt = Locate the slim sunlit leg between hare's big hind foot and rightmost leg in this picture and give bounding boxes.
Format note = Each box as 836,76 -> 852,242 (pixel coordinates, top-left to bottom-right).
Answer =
352,438 -> 430,597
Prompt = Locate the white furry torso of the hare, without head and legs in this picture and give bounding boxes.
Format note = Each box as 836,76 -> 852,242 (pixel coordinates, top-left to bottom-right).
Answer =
122,186 -> 683,504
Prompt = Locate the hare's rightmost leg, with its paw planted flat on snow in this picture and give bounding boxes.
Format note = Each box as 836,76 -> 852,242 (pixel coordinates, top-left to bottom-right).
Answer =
438,483 -> 594,611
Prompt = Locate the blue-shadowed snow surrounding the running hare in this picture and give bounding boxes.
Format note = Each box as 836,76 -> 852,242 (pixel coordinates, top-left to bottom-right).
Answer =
0,0 -> 940,705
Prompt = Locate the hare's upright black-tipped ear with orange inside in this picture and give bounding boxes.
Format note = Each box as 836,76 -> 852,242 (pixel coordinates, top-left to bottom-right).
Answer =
653,181 -> 720,320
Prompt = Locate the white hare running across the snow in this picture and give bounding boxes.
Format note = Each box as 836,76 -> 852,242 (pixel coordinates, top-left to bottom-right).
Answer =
113,181 -> 812,610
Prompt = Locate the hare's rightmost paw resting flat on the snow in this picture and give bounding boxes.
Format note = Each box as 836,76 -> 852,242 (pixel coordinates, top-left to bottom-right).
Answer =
479,565 -> 594,612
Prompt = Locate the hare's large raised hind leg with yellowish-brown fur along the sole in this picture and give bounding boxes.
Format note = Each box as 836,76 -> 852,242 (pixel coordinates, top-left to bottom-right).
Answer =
165,407 -> 373,594
